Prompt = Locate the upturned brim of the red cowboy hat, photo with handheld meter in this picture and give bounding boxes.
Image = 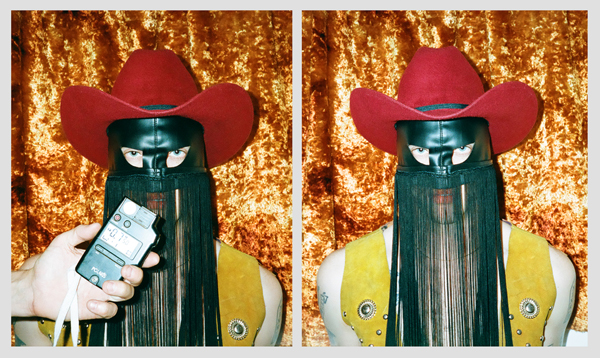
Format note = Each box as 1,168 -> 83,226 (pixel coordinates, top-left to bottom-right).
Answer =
60,83 -> 254,168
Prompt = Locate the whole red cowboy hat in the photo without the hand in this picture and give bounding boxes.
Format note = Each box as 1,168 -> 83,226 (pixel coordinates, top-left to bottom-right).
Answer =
350,47 -> 538,155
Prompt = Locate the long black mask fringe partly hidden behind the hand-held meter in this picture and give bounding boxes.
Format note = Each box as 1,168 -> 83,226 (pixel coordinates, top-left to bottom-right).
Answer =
90,173 -> 222,346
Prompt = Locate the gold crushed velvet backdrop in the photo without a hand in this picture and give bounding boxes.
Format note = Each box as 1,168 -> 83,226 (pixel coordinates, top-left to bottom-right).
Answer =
302,11 -> 588,346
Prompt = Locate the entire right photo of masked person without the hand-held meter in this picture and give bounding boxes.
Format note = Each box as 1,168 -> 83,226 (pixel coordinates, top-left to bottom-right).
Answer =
302,11 -> 588,347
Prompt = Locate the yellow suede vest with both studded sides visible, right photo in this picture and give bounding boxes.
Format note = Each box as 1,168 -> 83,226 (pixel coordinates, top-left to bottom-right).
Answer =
340,226 -> 556,346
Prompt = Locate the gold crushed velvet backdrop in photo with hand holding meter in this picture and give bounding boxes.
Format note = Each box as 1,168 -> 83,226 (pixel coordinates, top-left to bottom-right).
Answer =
11,11 -> 292,346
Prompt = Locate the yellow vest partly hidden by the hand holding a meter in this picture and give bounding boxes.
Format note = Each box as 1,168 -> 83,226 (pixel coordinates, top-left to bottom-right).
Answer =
38,243 -> 265,346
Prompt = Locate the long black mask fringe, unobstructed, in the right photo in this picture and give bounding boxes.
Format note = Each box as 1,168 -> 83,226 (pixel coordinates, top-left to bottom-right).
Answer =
386,166 -> 510,346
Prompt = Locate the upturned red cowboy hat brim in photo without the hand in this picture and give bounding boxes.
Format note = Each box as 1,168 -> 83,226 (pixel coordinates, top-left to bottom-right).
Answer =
350,81 -> 538,155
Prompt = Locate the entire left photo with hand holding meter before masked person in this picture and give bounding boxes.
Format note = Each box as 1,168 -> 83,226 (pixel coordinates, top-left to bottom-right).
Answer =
11,11 -> 292,347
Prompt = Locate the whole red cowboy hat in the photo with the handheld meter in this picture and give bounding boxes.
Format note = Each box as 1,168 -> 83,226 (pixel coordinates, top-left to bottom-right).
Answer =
60,50 -> 254,168
